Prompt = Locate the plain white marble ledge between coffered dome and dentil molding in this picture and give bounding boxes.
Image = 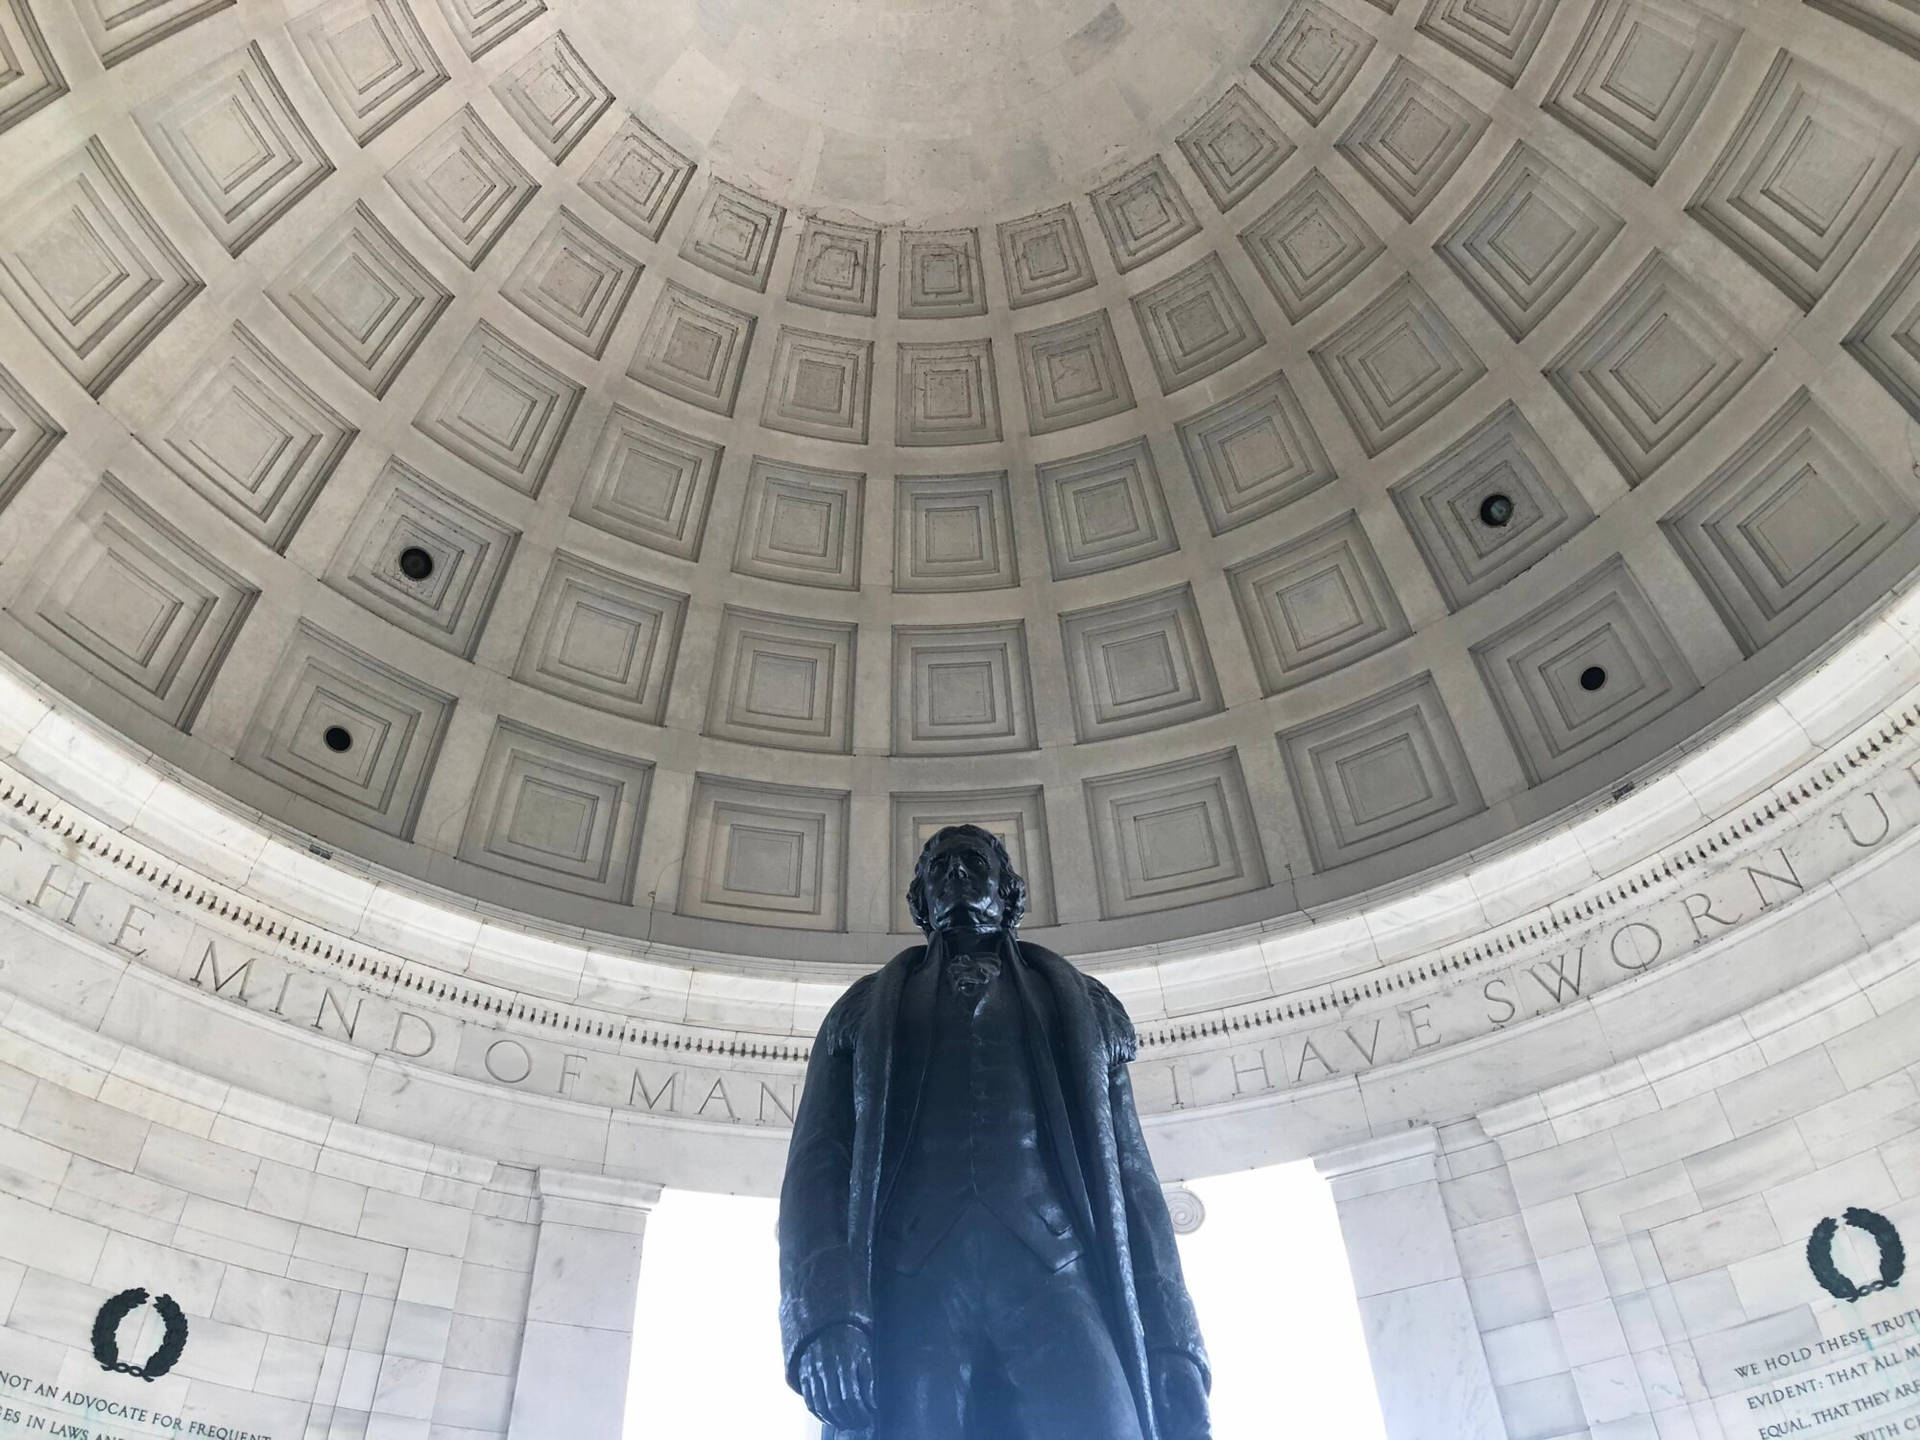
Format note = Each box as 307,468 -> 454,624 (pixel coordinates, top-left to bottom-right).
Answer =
0,514 -> 1920,1067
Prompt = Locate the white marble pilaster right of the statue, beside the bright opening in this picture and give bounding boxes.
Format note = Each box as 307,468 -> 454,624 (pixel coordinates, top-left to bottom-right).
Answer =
1313,1125 -> 1507,1440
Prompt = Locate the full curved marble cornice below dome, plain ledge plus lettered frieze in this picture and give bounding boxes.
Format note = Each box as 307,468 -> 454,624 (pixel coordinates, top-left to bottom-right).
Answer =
0,576 -> 1920,1187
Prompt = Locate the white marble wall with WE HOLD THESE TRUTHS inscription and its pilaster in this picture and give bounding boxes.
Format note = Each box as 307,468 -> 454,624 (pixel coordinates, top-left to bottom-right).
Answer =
1321,933 -> 1920,1440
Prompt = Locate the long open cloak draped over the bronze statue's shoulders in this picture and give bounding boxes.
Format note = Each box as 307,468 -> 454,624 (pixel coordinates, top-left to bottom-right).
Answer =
780,937 -> 1208,1440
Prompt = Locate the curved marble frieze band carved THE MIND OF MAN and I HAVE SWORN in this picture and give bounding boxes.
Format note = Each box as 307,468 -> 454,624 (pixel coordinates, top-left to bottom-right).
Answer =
0,691 -> 1920,1131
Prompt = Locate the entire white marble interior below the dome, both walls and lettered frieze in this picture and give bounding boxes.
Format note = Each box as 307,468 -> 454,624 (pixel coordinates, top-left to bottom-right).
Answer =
0,499 -> 1920,1440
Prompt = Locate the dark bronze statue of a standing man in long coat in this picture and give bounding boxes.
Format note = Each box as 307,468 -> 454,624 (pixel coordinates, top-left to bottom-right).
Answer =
780,826 -> 1212,1440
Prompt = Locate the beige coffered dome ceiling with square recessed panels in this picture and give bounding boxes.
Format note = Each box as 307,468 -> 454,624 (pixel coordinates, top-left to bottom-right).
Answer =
0,0 -> 1920,964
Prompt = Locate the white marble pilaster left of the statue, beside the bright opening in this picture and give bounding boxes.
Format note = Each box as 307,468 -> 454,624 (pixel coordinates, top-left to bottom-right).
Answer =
507,1167 -> 660,1440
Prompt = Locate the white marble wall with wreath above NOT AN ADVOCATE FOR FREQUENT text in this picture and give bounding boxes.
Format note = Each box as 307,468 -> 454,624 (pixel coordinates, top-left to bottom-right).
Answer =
0,998 -> 622,1440
